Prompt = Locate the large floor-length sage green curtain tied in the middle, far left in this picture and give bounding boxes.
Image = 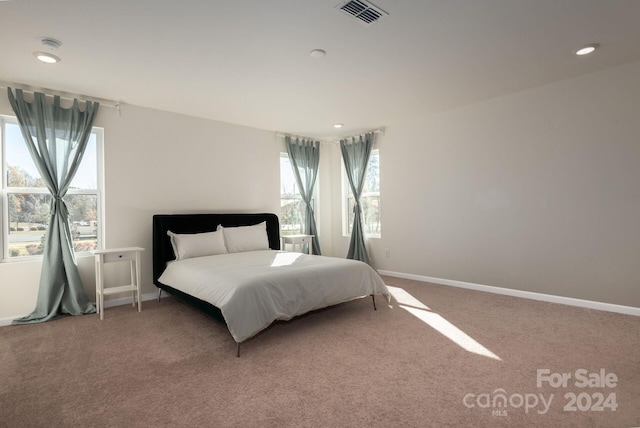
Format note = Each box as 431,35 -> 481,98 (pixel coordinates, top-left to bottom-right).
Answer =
7,88 -> 99,324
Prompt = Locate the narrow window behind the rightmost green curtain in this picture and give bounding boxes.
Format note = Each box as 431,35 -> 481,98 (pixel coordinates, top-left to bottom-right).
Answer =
342,149 -> 380,238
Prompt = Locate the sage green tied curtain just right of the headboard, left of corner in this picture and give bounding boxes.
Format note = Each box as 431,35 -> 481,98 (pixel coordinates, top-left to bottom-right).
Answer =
284,136 -> 321,255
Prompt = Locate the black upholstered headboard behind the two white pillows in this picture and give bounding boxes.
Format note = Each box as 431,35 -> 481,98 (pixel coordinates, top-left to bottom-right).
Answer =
153,213 -> 280,285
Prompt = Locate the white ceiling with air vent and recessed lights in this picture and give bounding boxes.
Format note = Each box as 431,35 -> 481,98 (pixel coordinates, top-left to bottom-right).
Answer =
0,0 -> 640,139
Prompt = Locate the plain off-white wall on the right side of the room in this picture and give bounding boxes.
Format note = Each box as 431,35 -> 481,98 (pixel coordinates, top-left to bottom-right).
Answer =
333,62 -> 640,307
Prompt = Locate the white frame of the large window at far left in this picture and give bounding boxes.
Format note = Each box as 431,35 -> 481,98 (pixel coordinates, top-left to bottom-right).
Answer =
0,115 -> 105,263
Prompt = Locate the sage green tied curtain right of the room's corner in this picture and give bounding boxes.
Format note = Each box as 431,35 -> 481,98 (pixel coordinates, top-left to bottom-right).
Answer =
340,132 -> 373,264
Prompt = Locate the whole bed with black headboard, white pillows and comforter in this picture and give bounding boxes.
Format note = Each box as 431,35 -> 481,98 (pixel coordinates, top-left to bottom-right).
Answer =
153,213 -> 390,357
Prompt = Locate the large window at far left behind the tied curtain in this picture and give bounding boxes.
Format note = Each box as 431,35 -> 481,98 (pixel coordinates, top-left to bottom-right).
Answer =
0,116 -> 103,260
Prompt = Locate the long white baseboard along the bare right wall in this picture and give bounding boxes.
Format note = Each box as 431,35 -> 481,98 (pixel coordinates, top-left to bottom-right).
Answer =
378,270 -> 640,317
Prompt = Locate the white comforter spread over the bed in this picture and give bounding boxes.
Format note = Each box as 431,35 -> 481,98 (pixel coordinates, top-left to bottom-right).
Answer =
159,250 -> 390,343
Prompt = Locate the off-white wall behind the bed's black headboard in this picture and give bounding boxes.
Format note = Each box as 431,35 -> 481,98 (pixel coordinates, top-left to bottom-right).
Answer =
0,96 -> 283,322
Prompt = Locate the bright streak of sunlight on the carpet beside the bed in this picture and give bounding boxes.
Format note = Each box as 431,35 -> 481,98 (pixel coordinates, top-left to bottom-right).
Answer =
387,285 -> 502,361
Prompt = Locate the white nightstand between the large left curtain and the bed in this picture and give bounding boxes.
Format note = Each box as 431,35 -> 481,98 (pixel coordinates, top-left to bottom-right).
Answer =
92,247 -> 144,319
